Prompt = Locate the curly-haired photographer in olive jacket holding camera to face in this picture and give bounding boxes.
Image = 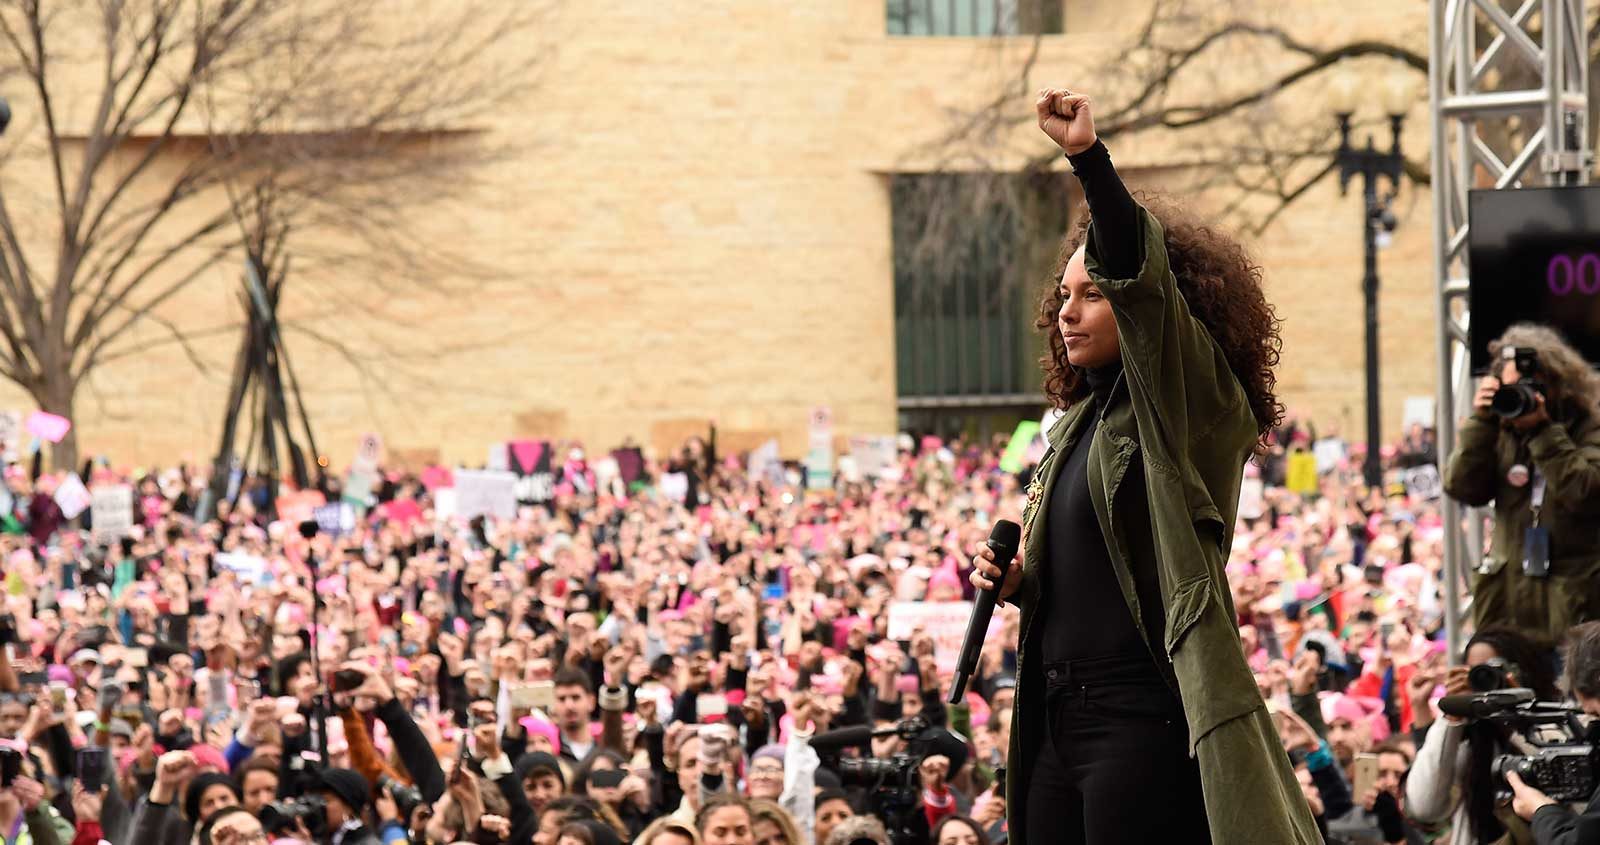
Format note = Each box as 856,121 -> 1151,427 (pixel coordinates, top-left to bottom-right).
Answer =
1445,323 -> 1600,642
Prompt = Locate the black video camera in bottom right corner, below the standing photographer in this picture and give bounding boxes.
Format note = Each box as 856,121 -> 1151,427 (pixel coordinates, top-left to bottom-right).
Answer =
1438,688 -> 1600,803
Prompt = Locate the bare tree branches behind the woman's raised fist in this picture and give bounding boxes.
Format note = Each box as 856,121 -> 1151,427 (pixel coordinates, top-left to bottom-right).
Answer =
901,0 -> 1600,300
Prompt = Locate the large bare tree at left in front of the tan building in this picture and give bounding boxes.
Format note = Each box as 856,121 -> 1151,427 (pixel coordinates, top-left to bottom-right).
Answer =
0,0 -> 555,466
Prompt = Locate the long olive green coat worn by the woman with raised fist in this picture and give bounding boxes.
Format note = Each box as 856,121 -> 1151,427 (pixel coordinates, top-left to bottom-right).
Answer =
1006,210 -> 1322,845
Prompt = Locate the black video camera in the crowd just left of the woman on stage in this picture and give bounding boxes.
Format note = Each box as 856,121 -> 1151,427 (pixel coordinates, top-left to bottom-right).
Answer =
811,715 -> 965,845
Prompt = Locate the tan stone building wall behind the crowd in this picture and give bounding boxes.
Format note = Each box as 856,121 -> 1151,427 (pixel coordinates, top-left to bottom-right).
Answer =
0,0 -> 1434,464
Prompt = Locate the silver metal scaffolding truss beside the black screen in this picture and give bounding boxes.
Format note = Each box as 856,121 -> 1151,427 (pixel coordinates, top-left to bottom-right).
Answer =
1427,0 -> 1594,661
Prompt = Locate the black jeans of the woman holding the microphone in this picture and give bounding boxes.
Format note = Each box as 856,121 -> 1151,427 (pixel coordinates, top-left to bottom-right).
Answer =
1027,656 -> 1211,845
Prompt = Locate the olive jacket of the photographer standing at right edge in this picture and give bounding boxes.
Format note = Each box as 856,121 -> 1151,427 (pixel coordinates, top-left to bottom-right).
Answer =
1445,413 -> 1600,642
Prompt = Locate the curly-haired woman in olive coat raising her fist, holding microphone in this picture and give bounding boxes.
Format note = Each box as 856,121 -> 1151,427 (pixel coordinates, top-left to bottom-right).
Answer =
971,90 -> 1322,845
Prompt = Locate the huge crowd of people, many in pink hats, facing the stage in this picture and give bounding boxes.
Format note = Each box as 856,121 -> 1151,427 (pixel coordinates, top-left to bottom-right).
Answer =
0,406 -> 1587,845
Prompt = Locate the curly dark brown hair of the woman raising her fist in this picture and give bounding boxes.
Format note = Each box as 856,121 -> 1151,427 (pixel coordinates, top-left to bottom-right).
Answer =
1034,194 -> 1283,451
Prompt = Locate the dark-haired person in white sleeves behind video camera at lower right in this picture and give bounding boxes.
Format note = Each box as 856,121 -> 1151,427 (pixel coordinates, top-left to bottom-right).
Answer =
1405,627 -> 1560,845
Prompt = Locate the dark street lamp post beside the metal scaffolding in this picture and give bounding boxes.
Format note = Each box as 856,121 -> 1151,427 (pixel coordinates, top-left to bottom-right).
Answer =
1334,76 -> 1408,487
